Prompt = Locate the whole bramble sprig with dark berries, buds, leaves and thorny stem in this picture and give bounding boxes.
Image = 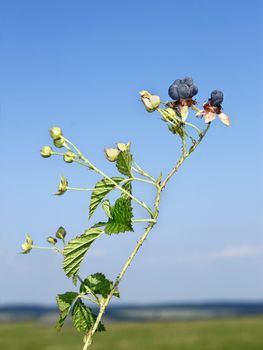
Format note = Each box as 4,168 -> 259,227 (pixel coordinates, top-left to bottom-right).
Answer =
22,77 -> 230,350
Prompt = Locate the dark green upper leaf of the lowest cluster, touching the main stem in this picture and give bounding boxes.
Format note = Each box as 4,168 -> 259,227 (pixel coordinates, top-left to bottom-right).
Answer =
80,273 -> 120,298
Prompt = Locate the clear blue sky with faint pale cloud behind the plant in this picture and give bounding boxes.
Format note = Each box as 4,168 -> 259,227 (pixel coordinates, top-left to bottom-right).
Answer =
0,0 -> 263,304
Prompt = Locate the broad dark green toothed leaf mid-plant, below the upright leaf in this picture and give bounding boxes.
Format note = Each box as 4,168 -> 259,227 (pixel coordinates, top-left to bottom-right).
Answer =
105,197 -> 133,234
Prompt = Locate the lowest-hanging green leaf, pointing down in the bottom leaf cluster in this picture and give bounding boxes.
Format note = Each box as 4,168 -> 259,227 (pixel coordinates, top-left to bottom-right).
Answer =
72,299 -> 105,332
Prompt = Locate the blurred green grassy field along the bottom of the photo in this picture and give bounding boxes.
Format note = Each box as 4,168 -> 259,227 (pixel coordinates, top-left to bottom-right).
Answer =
0,318 -> 263,350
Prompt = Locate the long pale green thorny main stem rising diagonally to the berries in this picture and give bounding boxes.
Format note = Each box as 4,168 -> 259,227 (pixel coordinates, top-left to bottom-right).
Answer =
83,123 -> 210,350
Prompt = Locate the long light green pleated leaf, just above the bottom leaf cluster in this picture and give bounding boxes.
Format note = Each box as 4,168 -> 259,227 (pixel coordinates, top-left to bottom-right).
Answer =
63,228 -> 103,277
